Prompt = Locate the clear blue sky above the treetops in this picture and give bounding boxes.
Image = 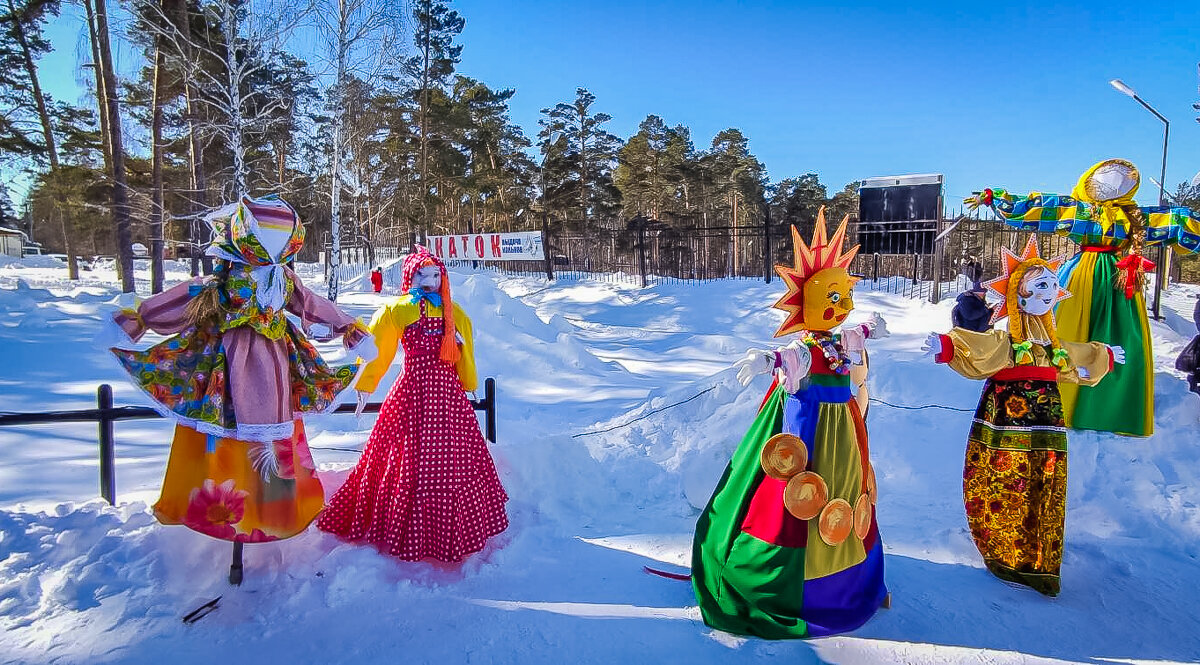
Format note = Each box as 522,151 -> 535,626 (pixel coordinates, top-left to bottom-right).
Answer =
32,0 -> 1200,203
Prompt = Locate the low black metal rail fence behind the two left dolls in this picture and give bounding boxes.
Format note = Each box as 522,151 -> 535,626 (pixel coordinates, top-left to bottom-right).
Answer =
0,377 -> 496,504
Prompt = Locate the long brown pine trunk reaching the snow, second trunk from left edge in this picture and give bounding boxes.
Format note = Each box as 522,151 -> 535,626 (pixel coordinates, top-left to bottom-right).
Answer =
85,0 -> 136,293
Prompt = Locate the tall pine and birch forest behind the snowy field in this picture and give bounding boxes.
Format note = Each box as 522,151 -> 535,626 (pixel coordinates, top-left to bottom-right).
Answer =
0,0 -> 1200,298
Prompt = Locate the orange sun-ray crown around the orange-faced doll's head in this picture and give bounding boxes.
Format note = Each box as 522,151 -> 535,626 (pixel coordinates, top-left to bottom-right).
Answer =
772,205 -> 858,337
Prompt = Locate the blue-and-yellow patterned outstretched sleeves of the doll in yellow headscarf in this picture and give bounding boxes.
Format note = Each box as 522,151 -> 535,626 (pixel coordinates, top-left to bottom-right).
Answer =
991,190 -> 1200,254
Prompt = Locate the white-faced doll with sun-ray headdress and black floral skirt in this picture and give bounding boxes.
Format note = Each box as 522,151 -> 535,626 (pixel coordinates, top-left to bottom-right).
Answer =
926,236 -> 1124,595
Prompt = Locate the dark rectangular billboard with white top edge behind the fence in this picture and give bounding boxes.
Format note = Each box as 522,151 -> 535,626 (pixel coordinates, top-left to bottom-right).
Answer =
858,174 -> 942,254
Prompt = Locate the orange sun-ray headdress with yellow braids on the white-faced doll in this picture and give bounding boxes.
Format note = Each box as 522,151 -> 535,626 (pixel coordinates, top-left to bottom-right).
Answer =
985,235 -> 1070,369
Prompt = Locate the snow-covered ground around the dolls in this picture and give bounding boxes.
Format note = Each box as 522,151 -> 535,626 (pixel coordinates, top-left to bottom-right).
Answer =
0,254 -> 1200,665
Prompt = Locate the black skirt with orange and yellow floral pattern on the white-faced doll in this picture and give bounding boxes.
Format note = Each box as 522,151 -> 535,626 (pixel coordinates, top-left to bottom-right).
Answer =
962,379 -> 1067,595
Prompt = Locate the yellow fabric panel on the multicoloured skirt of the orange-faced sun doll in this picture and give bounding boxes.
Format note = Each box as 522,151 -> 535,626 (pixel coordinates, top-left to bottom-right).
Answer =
804,403 -> 866,580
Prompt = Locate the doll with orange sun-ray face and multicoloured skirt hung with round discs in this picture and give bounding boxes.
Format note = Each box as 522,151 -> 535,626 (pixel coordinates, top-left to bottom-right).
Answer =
691,209 -> 887,639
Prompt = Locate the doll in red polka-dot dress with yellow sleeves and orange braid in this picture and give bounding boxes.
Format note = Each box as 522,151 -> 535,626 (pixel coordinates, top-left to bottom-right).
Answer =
317,247 -> 509,562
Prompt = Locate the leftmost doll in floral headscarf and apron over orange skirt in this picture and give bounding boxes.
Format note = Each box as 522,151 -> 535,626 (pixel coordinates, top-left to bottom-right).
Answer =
112,197 -> 374,543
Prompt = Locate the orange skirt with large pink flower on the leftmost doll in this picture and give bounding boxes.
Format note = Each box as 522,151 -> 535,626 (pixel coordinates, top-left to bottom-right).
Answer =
154,420 -> 325,543
